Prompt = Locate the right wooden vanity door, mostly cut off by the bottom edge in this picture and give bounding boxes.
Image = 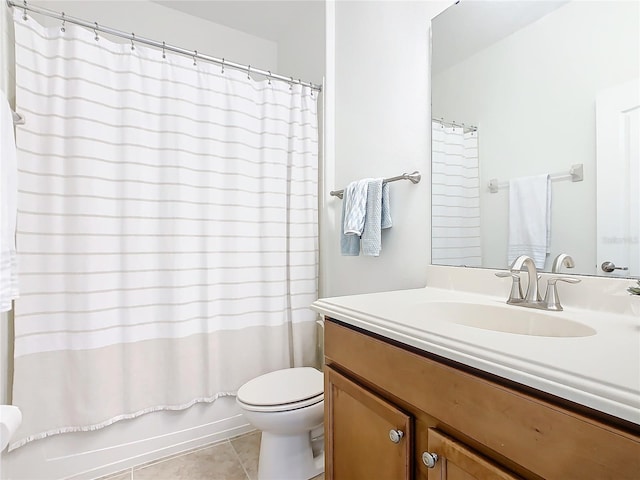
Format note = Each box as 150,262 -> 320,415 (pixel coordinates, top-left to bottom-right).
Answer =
420,428 -> 520,480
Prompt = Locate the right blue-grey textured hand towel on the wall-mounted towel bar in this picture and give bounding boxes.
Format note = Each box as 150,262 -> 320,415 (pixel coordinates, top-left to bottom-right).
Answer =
362,178 -> 392,257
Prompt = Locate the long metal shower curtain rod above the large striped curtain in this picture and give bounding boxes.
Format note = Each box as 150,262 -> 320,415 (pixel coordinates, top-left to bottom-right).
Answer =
7,0 -> 322,92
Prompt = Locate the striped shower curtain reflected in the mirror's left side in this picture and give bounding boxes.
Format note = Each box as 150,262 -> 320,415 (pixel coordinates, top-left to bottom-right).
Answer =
431,121 -> 482,267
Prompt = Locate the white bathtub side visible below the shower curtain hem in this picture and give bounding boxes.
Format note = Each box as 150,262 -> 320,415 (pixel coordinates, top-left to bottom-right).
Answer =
0,399 -> 254,480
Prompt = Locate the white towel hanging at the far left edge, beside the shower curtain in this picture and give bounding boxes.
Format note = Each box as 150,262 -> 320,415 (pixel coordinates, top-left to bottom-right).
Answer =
0,96 -> 18,312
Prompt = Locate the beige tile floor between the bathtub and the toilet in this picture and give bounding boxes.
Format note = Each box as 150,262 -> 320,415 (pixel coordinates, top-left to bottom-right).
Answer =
100,431 -> 324,480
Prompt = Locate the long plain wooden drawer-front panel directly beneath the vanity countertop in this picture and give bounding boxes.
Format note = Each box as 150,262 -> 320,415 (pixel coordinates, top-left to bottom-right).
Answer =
325,319 -> 640,480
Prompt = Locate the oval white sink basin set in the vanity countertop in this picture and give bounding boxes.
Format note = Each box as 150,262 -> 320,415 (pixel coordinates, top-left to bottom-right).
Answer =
420,302 -> 597,337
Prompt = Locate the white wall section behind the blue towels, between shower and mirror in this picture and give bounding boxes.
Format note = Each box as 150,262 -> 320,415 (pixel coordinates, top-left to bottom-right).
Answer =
321,1 -> 452,296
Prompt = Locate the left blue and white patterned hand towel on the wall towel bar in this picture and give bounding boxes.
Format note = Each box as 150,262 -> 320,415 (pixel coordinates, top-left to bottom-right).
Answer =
340,179 -> 369,257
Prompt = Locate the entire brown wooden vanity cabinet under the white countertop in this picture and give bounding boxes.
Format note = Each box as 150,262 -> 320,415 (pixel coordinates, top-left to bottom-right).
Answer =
325,318 -> 640,480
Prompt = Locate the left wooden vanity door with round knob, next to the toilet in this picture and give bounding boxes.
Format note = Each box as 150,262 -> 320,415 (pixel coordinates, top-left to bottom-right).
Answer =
324,367 -> 413,480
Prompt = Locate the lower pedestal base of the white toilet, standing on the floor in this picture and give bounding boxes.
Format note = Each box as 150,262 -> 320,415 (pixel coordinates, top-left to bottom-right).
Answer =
258,432 -> 324,480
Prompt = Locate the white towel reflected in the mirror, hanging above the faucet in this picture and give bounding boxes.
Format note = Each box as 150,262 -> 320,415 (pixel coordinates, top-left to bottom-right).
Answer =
507,175 -> 551,269
